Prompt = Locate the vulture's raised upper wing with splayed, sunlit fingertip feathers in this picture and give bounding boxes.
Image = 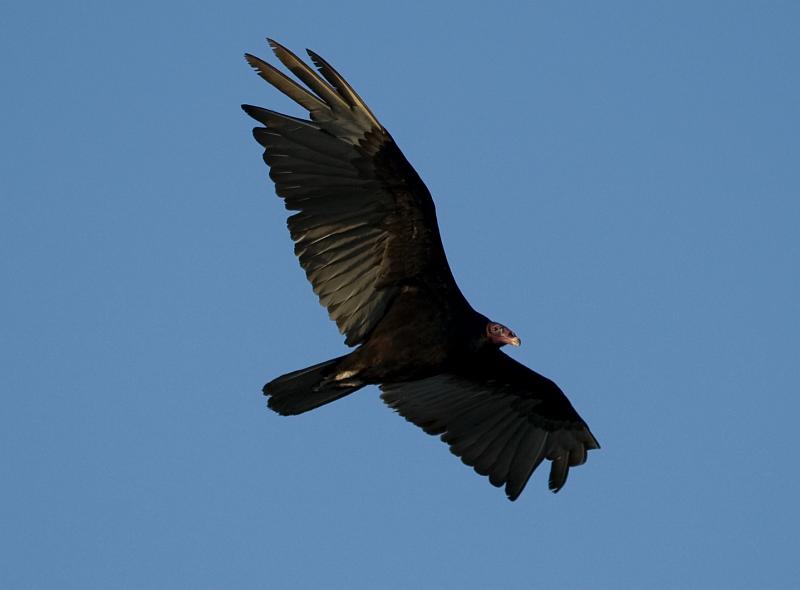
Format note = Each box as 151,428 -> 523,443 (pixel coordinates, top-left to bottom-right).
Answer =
242,40 -> 463,346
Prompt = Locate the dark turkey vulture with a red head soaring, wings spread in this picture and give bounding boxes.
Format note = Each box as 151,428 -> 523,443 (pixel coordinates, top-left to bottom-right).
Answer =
242,39 -> 599,500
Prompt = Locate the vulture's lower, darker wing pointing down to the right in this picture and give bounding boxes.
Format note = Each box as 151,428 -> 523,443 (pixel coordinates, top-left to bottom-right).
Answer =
381,350 -> 600,500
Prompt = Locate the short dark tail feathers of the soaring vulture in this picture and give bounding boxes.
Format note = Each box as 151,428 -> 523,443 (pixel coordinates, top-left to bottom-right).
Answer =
264,356 -> 365,416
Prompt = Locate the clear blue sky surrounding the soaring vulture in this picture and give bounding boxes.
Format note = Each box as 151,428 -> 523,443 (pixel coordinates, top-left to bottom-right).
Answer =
0,1 -> 800,589
